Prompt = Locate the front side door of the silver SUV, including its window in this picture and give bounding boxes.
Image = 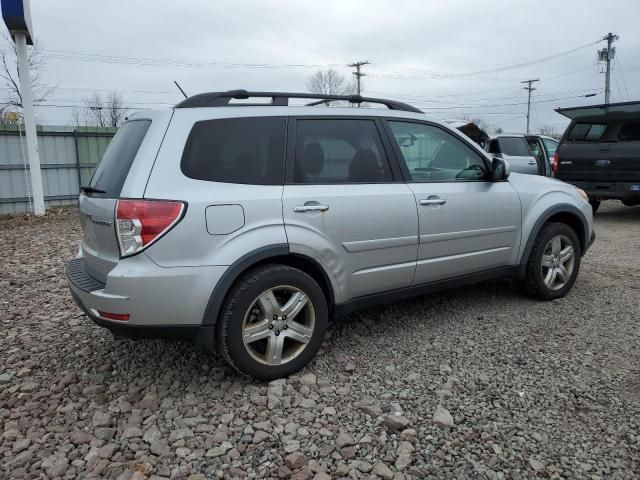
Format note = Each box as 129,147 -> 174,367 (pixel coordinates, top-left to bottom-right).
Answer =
388,120 -> 521,284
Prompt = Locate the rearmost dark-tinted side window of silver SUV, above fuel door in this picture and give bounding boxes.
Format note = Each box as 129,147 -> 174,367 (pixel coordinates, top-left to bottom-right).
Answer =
180,117 -> 285,185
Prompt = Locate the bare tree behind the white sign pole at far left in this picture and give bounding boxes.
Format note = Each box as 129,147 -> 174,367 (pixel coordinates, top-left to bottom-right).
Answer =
0,33 -> 54,111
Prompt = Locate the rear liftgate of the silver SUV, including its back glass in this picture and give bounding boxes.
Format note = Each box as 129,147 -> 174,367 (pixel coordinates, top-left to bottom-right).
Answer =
79,111 -> 171,282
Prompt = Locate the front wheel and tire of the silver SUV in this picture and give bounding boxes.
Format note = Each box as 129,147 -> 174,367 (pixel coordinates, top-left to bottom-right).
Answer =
522,222 -> 582,300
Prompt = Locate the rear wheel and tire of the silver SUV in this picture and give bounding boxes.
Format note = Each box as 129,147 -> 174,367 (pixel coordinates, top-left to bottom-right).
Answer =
216,265 -> 329,380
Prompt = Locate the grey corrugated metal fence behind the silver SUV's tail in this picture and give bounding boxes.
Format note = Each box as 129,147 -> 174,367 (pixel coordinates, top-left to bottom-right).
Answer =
0,125 -> 116,215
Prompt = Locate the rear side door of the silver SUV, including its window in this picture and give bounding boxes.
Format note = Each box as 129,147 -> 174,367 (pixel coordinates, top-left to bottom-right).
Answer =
282,117 -> 418,299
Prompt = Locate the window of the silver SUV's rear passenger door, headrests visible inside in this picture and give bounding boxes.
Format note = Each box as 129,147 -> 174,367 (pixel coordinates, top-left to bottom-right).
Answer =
294,119 -> 392,183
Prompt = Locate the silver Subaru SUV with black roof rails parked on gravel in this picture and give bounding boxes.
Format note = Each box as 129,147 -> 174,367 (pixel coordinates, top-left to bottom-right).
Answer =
67,90 -> 594,379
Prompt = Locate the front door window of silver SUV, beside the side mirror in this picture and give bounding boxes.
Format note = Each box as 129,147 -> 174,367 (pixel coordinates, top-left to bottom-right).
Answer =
389,121 -> 487,182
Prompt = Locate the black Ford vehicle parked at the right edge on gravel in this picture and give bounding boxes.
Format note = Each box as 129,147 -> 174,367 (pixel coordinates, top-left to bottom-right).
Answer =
553,101 -> 640,213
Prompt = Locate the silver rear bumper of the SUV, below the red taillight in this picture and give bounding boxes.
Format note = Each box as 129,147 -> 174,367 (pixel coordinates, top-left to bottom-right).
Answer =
66,254 -> 227,339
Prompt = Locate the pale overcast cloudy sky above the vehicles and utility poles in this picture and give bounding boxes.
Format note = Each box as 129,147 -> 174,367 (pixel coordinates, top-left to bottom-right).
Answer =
0,0 -> 640,133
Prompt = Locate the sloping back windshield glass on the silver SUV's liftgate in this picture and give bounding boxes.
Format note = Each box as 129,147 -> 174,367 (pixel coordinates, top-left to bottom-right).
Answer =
90,120 -> 151,198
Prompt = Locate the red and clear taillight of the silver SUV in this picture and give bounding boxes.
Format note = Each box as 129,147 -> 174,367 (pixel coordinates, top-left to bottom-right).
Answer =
116,200 -> 185,257
